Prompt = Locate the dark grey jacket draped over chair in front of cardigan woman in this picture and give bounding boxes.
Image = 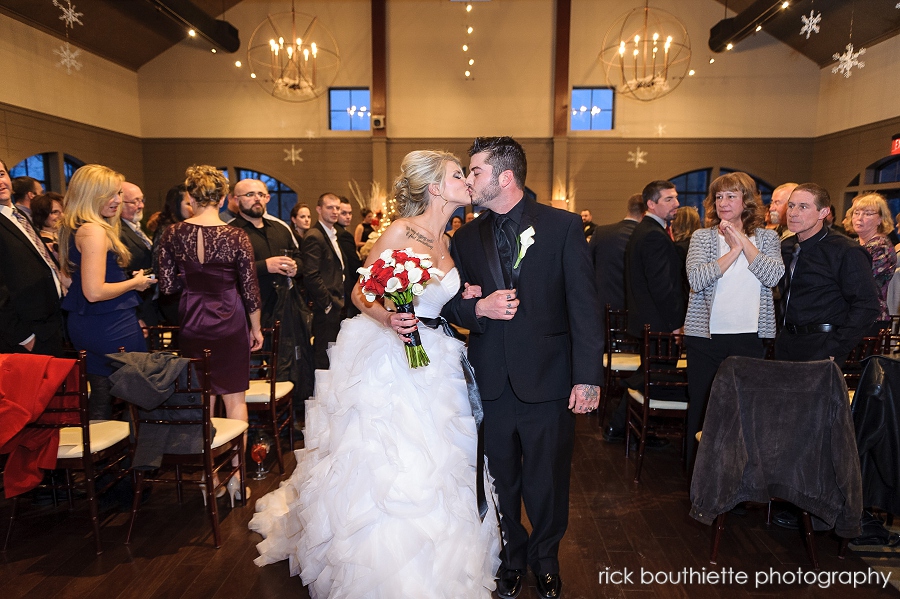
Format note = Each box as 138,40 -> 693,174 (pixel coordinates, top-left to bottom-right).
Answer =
690,357 -> 863,538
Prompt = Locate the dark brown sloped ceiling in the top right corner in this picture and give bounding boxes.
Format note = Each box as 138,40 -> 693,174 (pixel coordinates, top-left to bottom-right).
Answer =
712,0 -> 900,67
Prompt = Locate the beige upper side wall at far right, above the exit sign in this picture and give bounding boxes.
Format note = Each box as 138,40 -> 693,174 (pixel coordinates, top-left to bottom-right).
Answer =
816,36 -> 900,135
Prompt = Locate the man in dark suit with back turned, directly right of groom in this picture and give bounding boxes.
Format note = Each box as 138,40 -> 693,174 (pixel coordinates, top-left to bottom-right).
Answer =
589,193 -> 644,310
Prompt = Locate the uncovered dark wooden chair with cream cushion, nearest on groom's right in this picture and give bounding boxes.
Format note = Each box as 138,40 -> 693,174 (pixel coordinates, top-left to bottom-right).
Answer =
625,325 -> 687,483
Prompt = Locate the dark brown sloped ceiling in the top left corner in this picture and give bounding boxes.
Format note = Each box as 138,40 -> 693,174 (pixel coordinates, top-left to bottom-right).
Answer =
0,0 -> 241,71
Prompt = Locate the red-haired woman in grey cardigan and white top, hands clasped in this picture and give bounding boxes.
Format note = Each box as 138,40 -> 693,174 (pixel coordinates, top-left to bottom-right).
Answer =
684,172 -> 784,463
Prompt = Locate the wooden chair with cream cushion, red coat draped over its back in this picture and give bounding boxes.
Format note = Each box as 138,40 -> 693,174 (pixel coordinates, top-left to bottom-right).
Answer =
3,351 -> 131,555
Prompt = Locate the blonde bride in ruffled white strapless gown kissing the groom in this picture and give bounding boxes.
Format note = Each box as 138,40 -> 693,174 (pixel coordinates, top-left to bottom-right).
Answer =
250,151 -> 500,599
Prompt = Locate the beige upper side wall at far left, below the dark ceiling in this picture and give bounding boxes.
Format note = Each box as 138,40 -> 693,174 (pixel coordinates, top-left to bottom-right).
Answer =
0,14 -> 141,136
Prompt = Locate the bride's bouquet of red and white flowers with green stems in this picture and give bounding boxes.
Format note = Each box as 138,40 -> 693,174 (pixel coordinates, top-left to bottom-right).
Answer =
357,248 -> 444,368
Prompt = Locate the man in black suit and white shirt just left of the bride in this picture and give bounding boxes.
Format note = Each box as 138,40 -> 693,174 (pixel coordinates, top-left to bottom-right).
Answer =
301,193 -> 344,369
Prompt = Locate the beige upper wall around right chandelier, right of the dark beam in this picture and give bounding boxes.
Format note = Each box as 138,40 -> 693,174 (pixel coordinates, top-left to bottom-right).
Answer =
569,0 -> 819,138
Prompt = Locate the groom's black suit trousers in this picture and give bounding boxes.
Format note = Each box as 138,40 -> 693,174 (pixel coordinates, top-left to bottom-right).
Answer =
484,380 -> 575,574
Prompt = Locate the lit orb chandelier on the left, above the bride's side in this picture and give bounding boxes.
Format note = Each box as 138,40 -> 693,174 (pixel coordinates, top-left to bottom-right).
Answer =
247,1 -> 341,102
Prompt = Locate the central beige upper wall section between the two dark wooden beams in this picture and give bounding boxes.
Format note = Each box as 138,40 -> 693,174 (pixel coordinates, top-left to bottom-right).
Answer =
387,0 -> 554,139
